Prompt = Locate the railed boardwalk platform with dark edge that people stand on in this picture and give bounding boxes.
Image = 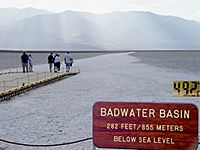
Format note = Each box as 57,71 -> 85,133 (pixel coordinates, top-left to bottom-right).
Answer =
0,67 -> 80,101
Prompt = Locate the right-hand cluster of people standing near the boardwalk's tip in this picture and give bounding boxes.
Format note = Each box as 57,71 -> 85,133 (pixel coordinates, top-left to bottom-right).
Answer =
48,52 -> 74,72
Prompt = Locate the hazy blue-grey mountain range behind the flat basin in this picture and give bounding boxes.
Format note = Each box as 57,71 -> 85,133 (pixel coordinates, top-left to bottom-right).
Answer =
0,8 -> 200,50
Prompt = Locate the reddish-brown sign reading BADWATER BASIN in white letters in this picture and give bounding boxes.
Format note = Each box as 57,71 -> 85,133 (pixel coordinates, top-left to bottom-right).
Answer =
93,102 -> 198,150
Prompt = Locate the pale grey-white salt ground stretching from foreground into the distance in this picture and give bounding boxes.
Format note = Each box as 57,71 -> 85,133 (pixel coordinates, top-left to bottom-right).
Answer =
0,53 -> 200,150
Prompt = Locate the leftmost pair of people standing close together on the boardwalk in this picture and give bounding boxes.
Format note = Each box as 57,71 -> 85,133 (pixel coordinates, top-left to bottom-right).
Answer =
21,52 -> 33,73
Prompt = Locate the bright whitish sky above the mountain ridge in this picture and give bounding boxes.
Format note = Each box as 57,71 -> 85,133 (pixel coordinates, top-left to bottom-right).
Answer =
0,0 -> 200,21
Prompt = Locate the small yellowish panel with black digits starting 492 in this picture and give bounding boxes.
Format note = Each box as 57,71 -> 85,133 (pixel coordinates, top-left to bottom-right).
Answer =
173,80 -> 200,97
